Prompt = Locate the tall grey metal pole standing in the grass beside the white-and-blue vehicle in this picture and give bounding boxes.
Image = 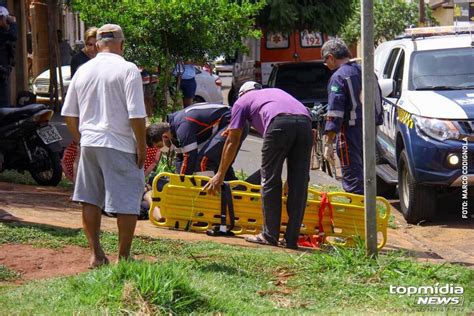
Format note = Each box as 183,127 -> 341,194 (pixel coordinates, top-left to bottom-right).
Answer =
361,0 -> 377,257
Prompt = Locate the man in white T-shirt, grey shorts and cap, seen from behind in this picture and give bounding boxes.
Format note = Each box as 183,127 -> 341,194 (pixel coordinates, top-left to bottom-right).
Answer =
61,24 -> 146,267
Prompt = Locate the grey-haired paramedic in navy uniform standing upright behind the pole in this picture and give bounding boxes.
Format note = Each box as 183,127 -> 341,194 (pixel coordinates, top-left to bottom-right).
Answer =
321,39 -> 382,194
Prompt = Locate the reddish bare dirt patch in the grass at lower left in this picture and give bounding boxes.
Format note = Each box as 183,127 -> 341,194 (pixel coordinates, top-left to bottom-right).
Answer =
0,244 -> 90,283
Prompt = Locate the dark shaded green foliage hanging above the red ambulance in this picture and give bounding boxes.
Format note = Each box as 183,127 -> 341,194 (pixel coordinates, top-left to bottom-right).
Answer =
257,0 -> 354,34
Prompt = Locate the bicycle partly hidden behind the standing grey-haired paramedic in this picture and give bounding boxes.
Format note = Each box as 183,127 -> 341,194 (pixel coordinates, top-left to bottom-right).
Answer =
310,103 -> 336,178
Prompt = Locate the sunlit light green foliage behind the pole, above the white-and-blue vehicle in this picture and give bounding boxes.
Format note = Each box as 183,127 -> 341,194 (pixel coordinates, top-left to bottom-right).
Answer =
340,0 -> 437,44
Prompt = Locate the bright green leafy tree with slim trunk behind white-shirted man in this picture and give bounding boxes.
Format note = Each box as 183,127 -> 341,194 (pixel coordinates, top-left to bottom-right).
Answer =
72,0 -> 264,112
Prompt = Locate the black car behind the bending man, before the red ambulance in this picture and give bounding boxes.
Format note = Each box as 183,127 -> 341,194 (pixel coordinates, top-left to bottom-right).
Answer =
268,62 -> 331,108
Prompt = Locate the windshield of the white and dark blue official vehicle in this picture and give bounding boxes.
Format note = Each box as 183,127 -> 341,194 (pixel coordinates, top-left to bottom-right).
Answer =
409,48 -> 474,90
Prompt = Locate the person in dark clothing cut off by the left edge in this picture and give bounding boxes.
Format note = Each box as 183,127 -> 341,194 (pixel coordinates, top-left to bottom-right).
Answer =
0,6 -> 17,108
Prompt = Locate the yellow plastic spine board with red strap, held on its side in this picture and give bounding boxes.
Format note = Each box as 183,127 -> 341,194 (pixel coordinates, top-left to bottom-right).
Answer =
150,173 -> 390,249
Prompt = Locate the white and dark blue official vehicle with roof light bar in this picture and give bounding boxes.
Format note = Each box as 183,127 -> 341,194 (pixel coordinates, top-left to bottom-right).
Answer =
375,26 -> 474,223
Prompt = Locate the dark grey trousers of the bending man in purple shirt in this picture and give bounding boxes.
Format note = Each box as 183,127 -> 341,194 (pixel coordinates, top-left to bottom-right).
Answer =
261,115 -> 313,247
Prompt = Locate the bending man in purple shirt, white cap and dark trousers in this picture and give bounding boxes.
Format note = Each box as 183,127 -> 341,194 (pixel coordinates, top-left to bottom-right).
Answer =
204,81 -> 313,248
